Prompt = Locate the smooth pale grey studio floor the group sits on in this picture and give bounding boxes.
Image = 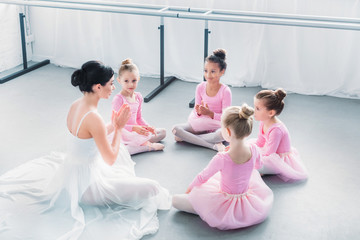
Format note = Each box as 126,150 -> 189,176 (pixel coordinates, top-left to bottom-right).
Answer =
0,65 -> 360,240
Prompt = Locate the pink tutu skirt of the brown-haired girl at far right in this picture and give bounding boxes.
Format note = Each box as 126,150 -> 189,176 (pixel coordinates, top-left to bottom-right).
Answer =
259,148 -> 308,182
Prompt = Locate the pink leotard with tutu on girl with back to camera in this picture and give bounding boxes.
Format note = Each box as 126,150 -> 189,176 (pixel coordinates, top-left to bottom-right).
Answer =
189,144 -> 273,230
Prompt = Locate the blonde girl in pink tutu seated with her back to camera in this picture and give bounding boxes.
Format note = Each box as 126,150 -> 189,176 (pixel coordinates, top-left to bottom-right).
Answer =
173,104 -> 273,230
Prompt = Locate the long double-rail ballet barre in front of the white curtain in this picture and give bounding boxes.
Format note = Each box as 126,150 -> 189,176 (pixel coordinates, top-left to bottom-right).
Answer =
0,0 -> 360,104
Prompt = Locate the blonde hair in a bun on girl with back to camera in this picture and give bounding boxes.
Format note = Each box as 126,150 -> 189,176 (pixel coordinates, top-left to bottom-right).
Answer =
221,103 -> 254,139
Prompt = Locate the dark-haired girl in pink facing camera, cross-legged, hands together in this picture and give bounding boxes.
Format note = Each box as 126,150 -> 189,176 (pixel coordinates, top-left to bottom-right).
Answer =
172,49 -> 231,151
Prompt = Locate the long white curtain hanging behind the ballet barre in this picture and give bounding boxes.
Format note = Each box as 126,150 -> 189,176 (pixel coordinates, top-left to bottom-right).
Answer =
26,0 -> 360,98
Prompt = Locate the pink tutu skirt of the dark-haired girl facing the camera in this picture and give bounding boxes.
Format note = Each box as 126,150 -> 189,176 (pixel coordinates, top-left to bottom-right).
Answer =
188,111 -> 221,132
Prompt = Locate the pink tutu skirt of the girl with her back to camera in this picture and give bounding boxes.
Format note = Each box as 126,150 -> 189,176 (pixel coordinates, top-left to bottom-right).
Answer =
189,170 -> 274,230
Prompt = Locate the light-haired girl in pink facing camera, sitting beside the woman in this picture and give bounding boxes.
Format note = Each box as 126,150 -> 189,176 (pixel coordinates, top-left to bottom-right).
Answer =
112,59 -> 166,155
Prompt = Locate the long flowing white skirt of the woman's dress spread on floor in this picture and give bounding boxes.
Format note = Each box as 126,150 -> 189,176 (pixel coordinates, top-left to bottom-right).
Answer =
0,145 -> 171,240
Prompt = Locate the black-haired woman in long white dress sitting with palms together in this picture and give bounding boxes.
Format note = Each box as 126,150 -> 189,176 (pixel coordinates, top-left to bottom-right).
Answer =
0,61 -> 171,239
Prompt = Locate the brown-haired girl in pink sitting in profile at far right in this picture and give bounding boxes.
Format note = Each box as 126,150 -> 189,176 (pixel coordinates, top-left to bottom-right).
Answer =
254,89 -> 307,181
